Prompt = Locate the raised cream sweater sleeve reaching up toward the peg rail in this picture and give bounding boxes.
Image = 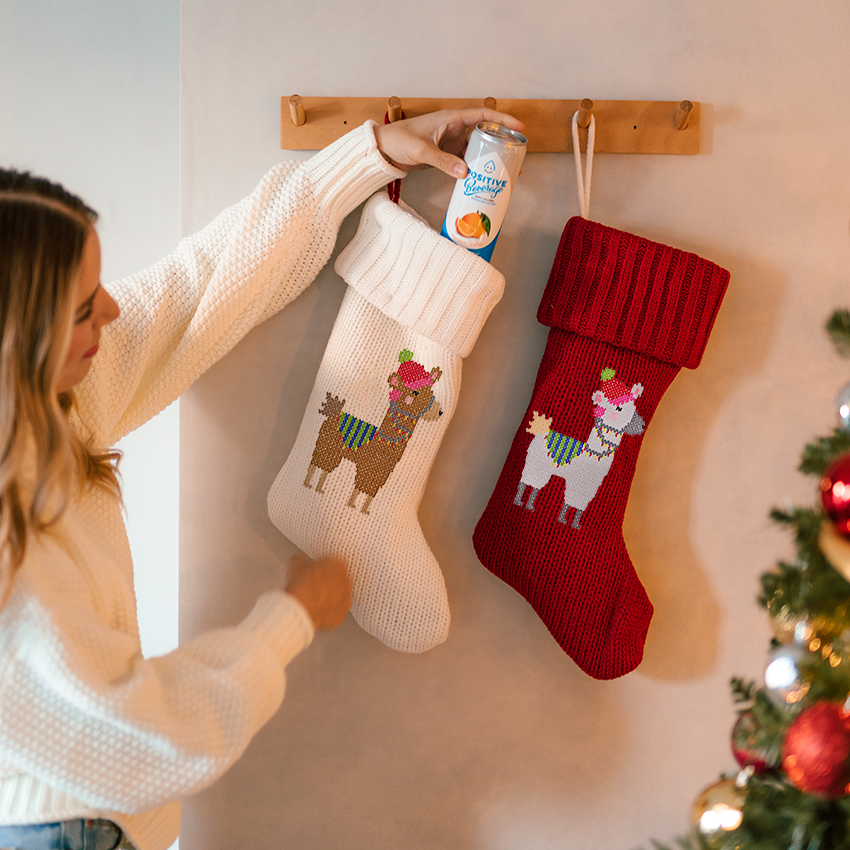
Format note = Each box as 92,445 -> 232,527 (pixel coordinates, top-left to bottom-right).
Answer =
77,122 -> 403,447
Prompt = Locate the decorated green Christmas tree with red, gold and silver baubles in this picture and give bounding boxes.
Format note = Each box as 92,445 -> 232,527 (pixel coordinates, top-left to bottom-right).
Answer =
653,310 -> 850,850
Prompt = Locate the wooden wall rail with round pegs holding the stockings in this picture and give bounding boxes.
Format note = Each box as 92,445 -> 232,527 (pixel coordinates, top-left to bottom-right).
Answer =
280,95 -> 699,154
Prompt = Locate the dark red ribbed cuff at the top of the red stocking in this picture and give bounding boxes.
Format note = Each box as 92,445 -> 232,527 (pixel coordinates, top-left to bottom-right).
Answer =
537,217 -> 729,369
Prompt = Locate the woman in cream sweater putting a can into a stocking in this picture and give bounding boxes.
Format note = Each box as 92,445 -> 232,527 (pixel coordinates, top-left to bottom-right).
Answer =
0,110 -> 522,850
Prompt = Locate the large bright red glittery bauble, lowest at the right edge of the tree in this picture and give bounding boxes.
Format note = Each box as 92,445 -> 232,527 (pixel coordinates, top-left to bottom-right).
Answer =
782,702 -> 850,797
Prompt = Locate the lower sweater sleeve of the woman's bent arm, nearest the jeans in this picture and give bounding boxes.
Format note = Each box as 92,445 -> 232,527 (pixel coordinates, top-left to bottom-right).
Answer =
0,540 -> 313,814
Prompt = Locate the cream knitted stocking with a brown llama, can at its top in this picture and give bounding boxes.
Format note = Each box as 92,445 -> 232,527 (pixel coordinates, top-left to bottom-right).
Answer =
268,194 -> 504,652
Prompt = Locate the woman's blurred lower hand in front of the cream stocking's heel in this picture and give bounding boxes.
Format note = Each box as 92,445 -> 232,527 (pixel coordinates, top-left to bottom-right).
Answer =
285,552 -> 351,631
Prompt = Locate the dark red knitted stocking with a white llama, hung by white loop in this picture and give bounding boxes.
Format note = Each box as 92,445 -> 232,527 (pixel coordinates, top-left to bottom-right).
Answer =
473,218 -> 729,679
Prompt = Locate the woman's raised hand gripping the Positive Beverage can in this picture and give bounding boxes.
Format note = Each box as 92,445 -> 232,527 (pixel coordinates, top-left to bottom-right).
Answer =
375,107 -> 525,179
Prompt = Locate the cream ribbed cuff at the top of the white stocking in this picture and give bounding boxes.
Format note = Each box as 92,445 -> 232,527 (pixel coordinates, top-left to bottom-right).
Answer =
335,193 -> 505,357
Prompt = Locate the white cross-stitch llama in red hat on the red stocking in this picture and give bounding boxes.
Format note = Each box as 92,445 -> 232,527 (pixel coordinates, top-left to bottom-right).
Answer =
514,368 -> 646,528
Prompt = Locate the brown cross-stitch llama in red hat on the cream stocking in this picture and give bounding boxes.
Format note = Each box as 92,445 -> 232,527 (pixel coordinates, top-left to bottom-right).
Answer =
304,349 -> 443,516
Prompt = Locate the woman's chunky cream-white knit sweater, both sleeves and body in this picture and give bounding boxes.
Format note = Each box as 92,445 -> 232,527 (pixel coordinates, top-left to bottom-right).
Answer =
0,119 -> 402,850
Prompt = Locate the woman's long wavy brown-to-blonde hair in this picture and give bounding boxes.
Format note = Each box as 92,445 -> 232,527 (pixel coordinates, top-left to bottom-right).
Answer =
0,169 -> 120,592
